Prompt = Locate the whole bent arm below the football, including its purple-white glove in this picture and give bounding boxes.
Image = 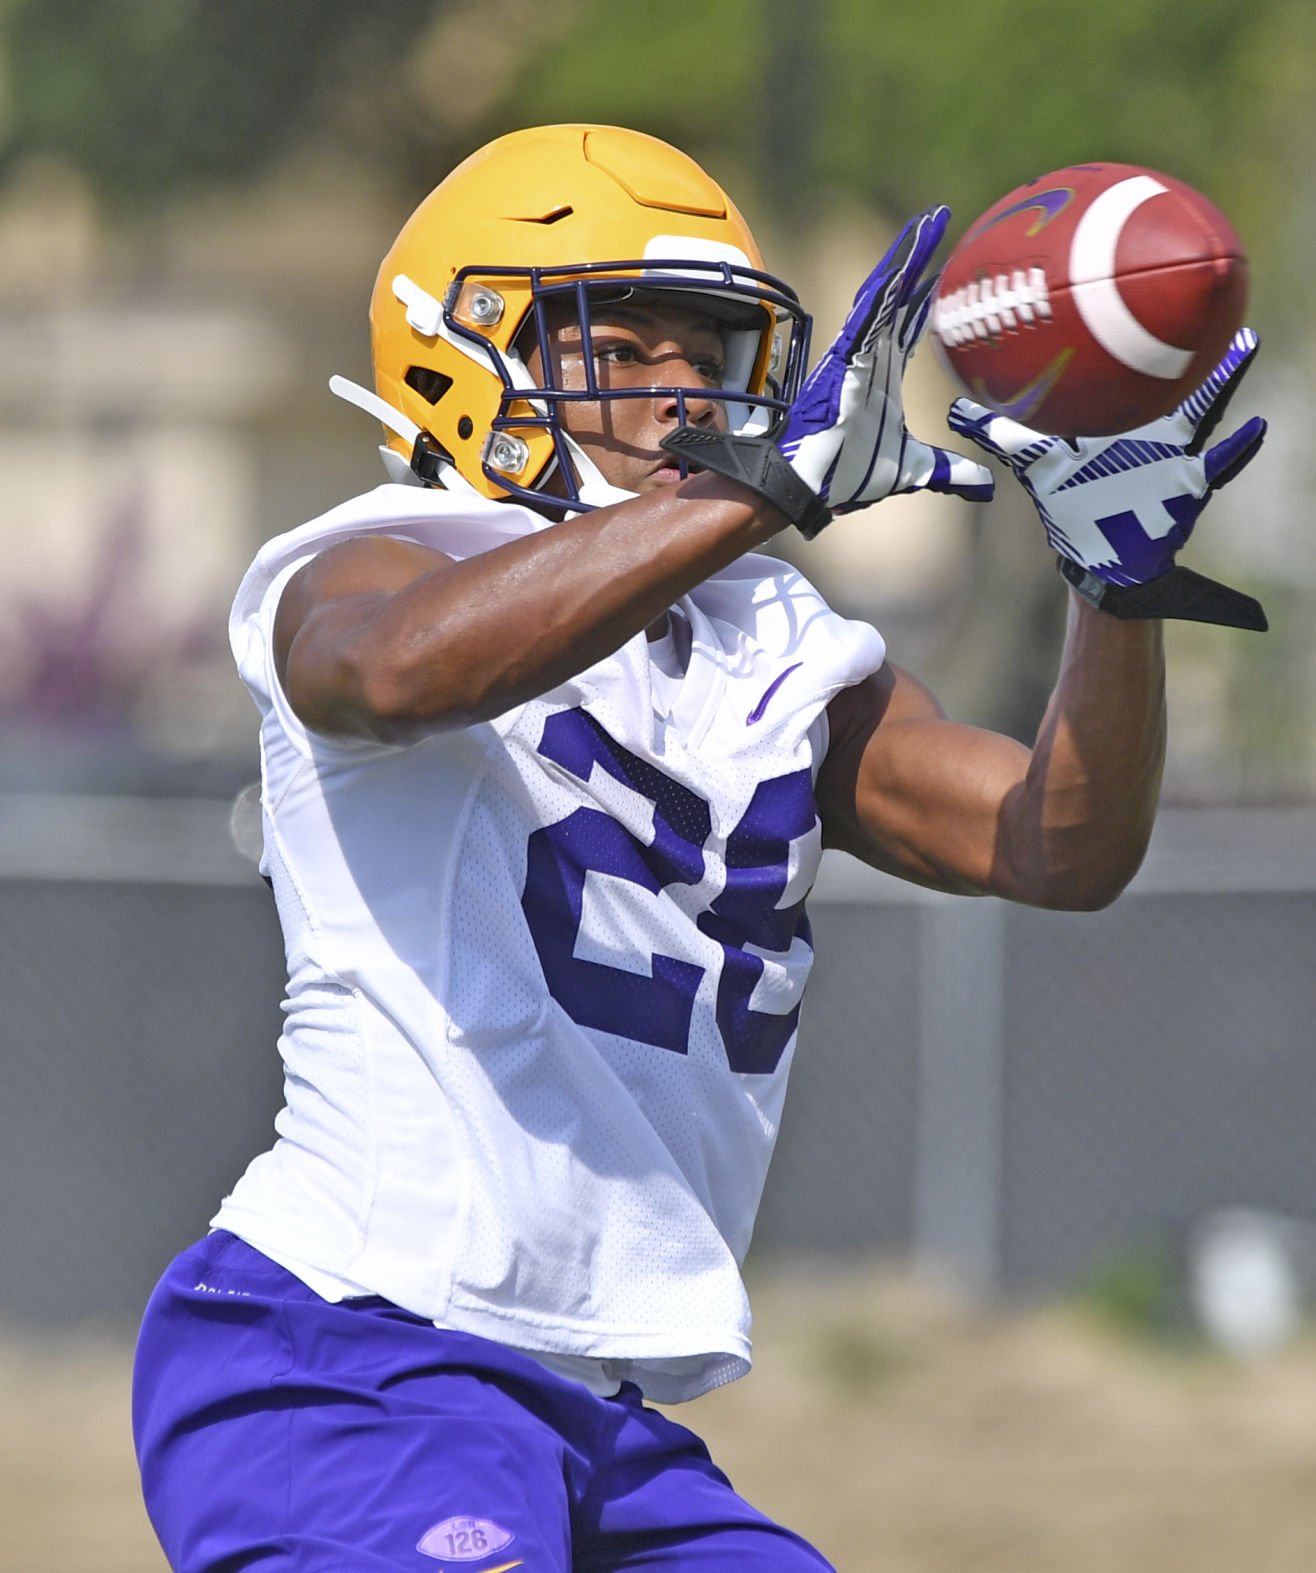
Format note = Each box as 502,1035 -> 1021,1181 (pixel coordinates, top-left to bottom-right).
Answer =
819,330 -> 1266,908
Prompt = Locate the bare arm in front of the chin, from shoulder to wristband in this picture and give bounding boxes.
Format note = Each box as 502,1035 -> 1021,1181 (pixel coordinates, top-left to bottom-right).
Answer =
274,475 -> 786,742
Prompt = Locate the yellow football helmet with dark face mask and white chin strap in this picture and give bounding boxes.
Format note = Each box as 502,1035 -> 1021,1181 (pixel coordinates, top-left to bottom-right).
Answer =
333,124 -> 810,511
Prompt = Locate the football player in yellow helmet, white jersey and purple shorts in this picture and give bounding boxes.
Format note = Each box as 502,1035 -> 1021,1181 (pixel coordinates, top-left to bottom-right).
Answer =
134,126 -> 1261,1573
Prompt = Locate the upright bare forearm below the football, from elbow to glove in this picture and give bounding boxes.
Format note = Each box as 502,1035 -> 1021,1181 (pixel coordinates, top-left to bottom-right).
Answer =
1002,596 -> 1165,909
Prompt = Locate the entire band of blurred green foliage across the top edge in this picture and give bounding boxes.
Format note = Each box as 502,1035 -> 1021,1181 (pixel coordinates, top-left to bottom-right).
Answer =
0,0 -> 1316,306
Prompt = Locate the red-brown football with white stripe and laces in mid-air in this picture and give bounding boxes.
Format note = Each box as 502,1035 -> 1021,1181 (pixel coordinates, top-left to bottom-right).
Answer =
931,164 -> 1247,437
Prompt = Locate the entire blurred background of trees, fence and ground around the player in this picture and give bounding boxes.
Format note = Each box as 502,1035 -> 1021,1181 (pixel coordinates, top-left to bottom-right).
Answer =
0,0 -> 1316,1573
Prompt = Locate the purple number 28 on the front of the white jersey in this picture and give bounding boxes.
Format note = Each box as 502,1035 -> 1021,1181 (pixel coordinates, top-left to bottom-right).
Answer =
522,709 -> 816,1074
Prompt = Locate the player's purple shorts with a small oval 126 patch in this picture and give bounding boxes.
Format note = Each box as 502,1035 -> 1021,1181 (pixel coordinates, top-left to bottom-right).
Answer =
132,1233 -> 830,1573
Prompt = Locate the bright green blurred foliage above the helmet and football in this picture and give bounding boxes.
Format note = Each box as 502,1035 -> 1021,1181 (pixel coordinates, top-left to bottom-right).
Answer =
508,0 -> 1316,327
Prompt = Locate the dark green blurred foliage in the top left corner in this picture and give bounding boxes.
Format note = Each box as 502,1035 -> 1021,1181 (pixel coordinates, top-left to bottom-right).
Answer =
0,0 -> 432,211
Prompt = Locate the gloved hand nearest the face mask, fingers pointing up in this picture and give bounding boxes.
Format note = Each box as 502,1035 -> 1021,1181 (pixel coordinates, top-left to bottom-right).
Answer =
777,208 -> 994,513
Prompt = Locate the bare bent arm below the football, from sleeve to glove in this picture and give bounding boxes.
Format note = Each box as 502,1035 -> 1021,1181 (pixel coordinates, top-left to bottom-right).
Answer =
818,598 -> 1165,909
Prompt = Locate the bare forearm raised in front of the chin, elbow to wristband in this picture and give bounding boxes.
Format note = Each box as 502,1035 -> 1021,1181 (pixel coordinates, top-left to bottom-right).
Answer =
341,475 -> 785,741
